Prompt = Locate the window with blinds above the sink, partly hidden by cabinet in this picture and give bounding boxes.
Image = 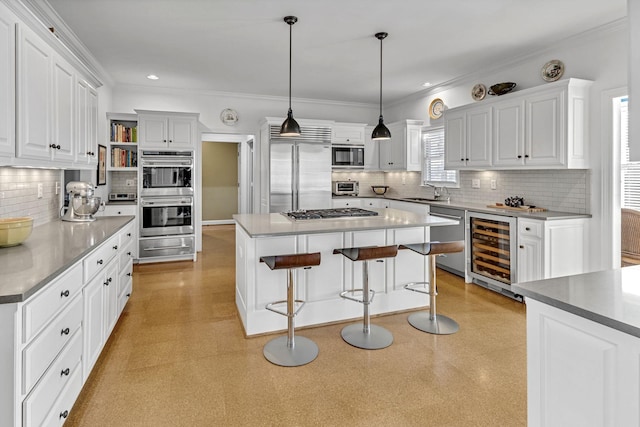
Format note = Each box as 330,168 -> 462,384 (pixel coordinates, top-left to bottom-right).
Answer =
422,127 -> 460,188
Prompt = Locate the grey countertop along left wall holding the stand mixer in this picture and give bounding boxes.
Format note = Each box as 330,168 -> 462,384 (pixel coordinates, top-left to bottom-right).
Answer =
0,215 -> 135,304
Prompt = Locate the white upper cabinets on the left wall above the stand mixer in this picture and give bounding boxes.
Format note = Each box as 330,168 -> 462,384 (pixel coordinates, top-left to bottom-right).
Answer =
13,17 -> 98,168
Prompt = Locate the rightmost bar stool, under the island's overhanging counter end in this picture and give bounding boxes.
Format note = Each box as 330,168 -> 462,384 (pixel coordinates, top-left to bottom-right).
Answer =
398,240 -> 464,335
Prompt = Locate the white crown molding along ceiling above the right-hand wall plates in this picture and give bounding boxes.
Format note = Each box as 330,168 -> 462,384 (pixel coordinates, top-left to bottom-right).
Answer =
388,17 -> 629,108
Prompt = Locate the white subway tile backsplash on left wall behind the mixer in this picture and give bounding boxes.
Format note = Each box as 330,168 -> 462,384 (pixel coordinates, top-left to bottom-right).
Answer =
0,167 -> 64,226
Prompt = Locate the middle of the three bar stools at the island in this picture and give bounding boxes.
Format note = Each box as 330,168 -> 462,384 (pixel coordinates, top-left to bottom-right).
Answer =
333,245 -> 398,350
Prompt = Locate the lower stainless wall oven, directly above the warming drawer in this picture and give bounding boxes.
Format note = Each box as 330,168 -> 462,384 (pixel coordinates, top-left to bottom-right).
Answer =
140,197 -> 194,237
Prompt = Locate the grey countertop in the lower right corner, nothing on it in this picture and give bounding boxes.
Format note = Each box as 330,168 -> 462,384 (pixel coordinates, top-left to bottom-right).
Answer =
511,266 -> 640,337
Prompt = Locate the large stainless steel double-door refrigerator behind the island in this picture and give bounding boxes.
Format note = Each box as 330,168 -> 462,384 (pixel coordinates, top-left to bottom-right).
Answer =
269,141 -> 331,212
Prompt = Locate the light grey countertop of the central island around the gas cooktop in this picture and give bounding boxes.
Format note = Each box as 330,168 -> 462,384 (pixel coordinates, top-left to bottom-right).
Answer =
233,208 -> 458,237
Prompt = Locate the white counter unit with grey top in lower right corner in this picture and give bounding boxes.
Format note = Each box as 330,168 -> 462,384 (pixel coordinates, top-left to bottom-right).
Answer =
512,266 -> 640,426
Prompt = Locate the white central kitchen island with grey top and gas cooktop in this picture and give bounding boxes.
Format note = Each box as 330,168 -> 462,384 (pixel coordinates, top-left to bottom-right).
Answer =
233,209 -> 458,336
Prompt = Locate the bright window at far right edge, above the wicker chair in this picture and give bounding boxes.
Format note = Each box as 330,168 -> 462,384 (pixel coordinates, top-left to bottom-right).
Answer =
619,97 -> 640,210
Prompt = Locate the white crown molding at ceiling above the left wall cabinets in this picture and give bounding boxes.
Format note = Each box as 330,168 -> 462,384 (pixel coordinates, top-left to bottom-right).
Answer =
13,0 -> 114,87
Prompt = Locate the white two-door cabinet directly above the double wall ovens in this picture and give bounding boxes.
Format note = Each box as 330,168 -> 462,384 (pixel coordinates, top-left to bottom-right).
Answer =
136,110 -> 199,150
